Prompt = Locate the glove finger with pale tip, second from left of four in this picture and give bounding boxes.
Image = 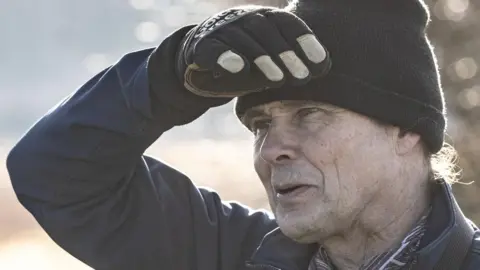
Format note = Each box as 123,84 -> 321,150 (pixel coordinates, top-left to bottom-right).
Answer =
216,25 -> 285,87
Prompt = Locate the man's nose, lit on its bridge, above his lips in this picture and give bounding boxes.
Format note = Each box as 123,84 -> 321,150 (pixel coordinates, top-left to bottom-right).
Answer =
259,127 -> 299,165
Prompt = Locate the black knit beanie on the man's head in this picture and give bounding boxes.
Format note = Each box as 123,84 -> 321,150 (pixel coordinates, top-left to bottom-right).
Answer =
235,0 -> 446,153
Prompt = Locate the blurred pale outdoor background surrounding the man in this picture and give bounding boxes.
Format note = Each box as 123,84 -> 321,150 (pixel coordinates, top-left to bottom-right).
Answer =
0,0 -> 480,270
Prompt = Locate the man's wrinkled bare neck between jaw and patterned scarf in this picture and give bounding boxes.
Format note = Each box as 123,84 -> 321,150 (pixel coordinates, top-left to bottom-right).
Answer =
321,172 -> 430,270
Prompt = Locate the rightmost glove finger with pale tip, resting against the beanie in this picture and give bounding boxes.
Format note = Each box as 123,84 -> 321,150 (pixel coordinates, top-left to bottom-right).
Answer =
265,11 -> 331,77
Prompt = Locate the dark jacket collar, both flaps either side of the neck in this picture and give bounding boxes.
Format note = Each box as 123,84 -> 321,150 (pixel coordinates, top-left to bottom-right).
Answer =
251,182 -> 464,270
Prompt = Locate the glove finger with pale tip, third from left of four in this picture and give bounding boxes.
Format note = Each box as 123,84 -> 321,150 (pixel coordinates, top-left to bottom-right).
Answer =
242,13 -> 310,85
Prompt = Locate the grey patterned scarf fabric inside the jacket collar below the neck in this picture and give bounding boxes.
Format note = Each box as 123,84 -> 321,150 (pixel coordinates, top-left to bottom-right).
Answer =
310,209 -> 431,270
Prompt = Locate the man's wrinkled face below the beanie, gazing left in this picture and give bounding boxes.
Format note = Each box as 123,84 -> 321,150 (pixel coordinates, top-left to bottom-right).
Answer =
243,101 -> 395,242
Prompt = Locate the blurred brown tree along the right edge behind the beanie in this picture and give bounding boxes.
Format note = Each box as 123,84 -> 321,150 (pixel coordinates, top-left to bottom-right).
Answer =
427,0 -> 480,224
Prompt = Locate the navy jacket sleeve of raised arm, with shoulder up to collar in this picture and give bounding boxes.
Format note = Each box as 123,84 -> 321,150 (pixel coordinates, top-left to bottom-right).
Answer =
7,26 -> 273,270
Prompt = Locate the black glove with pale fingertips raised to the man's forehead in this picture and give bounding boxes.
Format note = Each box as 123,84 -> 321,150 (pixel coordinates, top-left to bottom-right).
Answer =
176,6 -> 331,98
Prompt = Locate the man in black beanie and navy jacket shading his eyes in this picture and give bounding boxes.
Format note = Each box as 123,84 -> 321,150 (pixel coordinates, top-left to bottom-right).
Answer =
7,0 -> 480,270
